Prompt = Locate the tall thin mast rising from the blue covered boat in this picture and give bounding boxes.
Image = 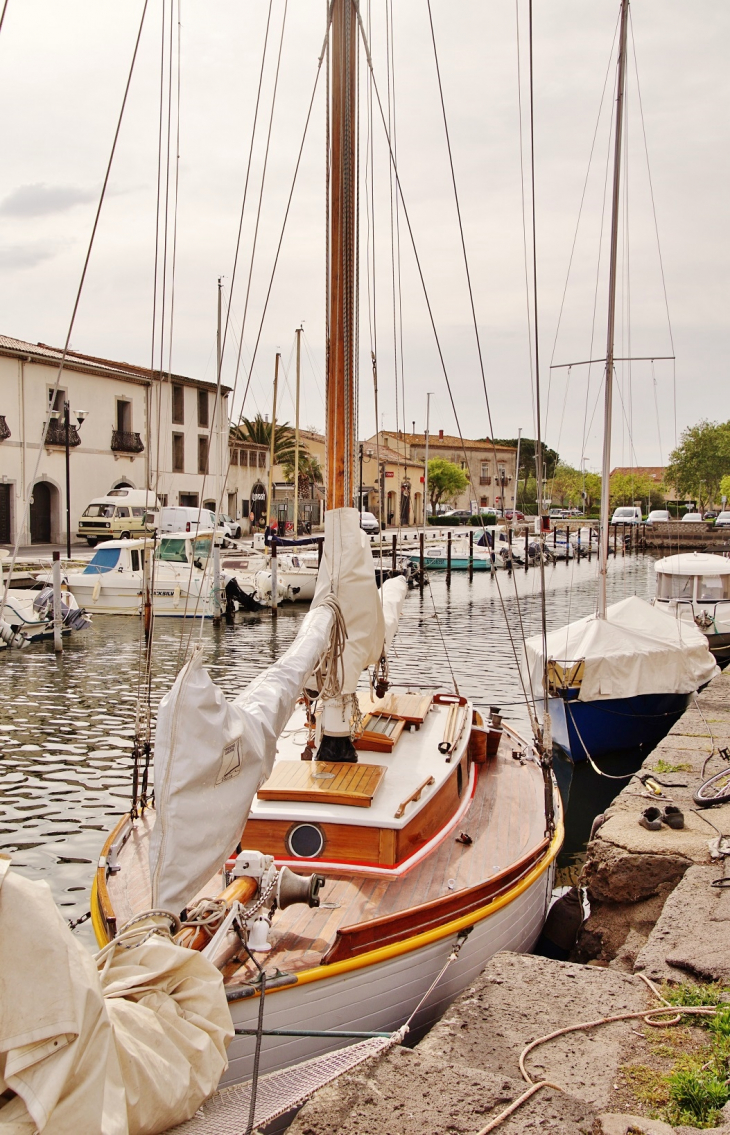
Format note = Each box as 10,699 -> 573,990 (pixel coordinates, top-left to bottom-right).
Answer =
598,0 -> 629,619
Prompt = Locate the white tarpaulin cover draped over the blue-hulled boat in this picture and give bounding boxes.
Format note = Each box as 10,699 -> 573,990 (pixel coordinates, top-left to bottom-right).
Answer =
525,595 -> 720,701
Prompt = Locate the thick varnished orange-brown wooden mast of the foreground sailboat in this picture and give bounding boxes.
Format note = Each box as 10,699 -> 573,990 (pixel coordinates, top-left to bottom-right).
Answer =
327,0 -> 358,508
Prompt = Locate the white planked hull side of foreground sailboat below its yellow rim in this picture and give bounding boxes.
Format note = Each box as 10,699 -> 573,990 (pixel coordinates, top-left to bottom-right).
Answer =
220,864 -> 554,1087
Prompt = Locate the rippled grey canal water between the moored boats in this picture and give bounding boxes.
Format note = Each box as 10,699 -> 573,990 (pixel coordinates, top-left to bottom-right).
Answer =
0,555 -> 654,949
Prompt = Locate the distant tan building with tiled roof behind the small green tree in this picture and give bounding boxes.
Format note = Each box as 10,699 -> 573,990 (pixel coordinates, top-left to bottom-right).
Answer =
366,429 -> 517,512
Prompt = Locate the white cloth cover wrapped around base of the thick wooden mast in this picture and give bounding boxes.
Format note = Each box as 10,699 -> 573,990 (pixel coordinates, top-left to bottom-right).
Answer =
312,508 -> 385,693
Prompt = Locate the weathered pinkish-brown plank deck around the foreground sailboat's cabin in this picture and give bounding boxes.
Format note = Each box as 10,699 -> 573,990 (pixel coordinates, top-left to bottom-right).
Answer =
107,726 -> 545,986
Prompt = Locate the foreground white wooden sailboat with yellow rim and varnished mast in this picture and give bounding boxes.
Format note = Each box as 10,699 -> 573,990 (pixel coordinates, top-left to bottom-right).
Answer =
92,0 -> 563,1084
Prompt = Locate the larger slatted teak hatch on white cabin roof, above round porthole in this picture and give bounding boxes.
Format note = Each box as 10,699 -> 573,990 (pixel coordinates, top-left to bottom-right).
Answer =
257,760 -> 387,808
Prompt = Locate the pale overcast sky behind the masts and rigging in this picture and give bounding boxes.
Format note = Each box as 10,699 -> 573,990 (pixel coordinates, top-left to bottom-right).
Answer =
0,0 -> 730,469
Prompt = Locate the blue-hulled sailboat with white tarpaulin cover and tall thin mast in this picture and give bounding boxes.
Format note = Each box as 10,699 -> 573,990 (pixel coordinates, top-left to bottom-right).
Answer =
525,0 -> 719,760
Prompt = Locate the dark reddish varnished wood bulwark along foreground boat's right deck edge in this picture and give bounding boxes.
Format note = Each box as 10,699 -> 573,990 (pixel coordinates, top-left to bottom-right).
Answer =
322,839 -> 549,965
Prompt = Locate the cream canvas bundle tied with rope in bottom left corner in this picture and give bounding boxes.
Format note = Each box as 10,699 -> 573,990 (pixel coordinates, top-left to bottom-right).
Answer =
0,857 -> 233,1135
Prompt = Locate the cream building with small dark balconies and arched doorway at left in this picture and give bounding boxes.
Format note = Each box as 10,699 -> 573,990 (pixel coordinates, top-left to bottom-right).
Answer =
0,336 -> 229,544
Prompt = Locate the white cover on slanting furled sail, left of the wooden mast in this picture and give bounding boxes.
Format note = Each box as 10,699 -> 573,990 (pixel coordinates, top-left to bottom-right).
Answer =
150,603 -> 338,914
